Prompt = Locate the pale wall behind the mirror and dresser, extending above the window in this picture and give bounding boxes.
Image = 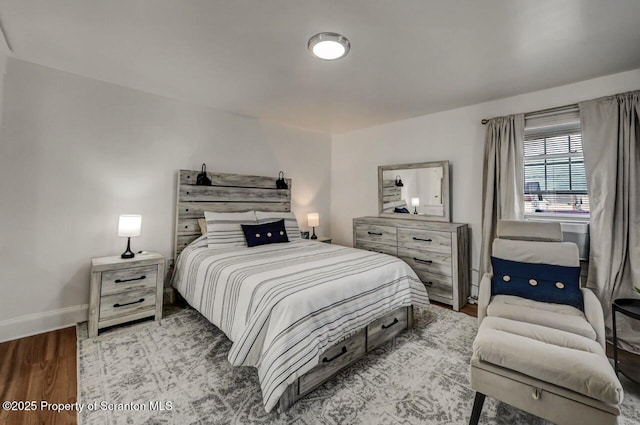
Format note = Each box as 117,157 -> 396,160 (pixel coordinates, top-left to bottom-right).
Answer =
331,69 -> 640,294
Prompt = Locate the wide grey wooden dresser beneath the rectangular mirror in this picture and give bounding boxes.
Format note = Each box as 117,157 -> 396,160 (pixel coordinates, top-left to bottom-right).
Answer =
353,217 -> 469,311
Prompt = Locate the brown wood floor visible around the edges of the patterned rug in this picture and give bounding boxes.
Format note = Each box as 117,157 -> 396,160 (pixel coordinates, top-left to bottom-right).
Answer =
0,302 -> 640,425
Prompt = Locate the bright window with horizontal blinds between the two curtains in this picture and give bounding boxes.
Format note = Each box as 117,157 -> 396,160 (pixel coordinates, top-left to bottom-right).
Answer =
524,109 -> 589,219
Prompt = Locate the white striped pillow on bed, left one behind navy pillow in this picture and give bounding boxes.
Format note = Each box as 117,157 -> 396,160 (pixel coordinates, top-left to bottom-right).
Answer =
204,211 -> 257,248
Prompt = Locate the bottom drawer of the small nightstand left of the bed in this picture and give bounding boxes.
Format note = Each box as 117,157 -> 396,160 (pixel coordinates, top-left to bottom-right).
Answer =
100,286 -> 156,321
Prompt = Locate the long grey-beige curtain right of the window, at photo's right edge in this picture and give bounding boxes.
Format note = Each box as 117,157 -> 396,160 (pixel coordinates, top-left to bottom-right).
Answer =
579,91 -> 640,354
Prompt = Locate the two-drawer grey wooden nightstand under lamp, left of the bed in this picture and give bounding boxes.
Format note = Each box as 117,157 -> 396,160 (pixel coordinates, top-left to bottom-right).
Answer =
89,252 -> 165,337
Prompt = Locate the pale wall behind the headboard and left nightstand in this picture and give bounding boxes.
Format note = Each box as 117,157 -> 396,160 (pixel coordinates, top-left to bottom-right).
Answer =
0,59 -> 331,340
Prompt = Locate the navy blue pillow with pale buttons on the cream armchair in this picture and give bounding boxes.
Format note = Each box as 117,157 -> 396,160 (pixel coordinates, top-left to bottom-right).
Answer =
491,257 -> 584,311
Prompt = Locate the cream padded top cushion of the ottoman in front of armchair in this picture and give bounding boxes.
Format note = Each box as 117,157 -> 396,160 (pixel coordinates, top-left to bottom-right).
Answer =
473,317 -> 623,404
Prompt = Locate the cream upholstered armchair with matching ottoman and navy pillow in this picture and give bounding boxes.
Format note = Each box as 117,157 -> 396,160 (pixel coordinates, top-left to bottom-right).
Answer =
469,221 -> 623,425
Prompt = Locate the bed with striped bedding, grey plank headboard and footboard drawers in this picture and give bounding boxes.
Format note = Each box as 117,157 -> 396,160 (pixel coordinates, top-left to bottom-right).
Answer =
172,170 -> 429,411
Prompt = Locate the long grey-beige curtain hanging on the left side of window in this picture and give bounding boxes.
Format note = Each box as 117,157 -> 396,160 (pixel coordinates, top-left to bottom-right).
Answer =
479,114 -> 524,278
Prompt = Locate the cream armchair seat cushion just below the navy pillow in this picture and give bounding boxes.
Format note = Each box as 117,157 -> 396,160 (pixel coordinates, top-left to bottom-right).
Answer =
487,295 -> 597,340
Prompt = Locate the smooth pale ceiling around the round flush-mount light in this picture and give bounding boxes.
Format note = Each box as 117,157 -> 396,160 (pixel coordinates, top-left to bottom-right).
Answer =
0,0 -> 640,133
